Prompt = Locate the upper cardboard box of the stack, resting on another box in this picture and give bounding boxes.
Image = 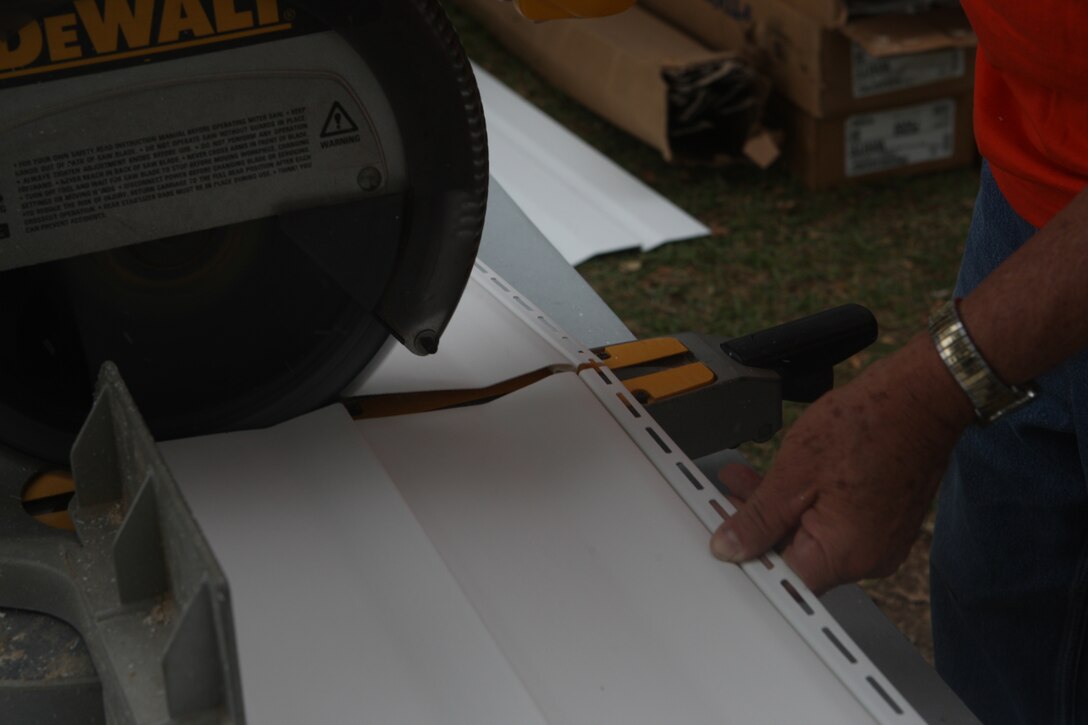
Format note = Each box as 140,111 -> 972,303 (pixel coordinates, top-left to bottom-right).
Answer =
643,0 -> 977,118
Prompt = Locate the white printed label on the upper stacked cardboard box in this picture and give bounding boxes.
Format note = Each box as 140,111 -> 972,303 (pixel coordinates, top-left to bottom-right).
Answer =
850,42 -> 967,98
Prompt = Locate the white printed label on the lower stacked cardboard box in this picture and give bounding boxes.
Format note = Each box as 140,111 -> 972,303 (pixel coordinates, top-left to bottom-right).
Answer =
844,98 -> 955,176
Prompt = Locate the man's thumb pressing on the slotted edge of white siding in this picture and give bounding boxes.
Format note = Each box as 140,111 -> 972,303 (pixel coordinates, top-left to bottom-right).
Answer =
710,481 -> 808,563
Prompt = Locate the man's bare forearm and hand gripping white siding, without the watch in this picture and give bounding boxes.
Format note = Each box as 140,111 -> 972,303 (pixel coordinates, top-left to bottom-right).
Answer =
710,181 -> 1088,592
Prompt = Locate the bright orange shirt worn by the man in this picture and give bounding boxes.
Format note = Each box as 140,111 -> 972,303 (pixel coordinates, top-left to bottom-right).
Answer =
962,0 -> 1088,226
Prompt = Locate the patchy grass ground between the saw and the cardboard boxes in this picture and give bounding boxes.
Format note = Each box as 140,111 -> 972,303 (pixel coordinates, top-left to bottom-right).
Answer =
447,3 -> 978,650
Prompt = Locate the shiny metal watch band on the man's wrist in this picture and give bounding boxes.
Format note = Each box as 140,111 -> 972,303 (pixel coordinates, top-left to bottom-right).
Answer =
929,299 -> 1036,426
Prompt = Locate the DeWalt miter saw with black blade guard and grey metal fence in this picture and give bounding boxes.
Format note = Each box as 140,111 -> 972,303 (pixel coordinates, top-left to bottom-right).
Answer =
0,0 -> 868,723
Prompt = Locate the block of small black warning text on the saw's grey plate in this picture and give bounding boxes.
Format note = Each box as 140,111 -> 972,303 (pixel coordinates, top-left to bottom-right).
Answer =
17,107 -> 312,234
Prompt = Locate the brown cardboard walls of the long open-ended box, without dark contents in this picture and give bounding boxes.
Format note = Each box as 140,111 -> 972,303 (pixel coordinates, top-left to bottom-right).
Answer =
458,0 -> 769,162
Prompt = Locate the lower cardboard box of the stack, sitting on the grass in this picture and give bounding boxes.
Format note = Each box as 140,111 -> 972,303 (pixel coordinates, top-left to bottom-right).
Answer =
783,93 -> 976,189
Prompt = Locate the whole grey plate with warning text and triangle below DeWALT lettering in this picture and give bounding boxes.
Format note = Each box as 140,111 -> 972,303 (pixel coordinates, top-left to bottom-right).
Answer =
0,62 -> 387,269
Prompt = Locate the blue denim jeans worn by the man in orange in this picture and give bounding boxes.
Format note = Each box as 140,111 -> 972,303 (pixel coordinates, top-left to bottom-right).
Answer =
930,165 -> 1088,725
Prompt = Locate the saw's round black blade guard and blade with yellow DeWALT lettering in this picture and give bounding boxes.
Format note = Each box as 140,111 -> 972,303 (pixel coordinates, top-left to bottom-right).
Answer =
0,0 -> 487,460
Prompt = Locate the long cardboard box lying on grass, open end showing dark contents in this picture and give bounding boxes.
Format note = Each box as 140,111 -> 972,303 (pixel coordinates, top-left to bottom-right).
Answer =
459,0 -> 778,165
